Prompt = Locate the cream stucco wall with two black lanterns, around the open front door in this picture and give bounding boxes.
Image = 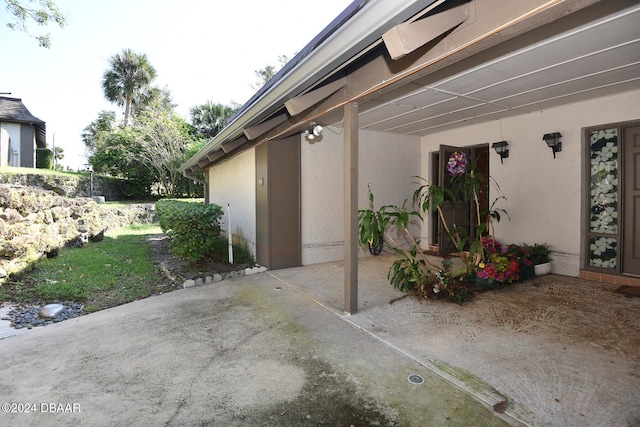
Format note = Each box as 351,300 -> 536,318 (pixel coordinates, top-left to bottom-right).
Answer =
422,91 -> 640,276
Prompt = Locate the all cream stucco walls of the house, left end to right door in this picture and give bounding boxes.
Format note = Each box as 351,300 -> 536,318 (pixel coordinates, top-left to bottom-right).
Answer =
208,91 -> 640,276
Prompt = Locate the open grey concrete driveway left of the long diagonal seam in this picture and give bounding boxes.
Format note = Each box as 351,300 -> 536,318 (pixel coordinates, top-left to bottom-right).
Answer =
0,265 -> 507,427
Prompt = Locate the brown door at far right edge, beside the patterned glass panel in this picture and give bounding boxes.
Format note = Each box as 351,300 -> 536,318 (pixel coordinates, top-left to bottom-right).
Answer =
622,126 -> 640,275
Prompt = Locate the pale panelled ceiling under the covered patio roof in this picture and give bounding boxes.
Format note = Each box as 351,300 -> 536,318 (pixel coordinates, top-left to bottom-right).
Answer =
359,2 -> 640,136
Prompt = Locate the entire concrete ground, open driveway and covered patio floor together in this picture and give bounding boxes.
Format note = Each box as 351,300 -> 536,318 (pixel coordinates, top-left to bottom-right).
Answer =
0,256 -> 640,426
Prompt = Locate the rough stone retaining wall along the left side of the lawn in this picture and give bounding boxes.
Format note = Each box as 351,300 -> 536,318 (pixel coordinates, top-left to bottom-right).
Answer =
0,184 -> 155,284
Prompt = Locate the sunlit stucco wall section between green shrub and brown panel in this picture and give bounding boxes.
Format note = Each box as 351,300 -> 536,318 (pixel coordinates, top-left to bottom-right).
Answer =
209,149 -> 256,255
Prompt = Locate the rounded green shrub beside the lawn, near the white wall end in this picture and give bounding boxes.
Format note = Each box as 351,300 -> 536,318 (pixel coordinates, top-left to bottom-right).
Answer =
156,199 -> 223,262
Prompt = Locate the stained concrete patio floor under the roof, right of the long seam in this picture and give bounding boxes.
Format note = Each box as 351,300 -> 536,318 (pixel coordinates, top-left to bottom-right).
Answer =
269,256 -> 640,426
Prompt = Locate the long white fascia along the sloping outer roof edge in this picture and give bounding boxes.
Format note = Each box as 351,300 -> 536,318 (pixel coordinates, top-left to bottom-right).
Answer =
181,0 -> 437,174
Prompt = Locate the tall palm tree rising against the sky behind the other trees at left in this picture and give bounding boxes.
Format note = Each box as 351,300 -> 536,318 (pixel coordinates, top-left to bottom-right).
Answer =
102,49 -> 156,127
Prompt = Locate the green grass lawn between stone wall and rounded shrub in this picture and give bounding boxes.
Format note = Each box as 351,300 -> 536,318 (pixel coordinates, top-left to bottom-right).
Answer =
0,224 -> 180,312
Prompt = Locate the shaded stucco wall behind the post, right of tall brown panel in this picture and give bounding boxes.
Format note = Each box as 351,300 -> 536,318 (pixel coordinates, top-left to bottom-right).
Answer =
301,126 -> 420,265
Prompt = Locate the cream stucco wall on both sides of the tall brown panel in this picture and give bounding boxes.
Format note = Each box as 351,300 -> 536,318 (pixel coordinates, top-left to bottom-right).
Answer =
208,126 -> 420,265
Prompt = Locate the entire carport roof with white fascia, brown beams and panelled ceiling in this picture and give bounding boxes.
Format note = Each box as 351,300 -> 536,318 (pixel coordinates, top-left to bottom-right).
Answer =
182,0 -> 640,174
